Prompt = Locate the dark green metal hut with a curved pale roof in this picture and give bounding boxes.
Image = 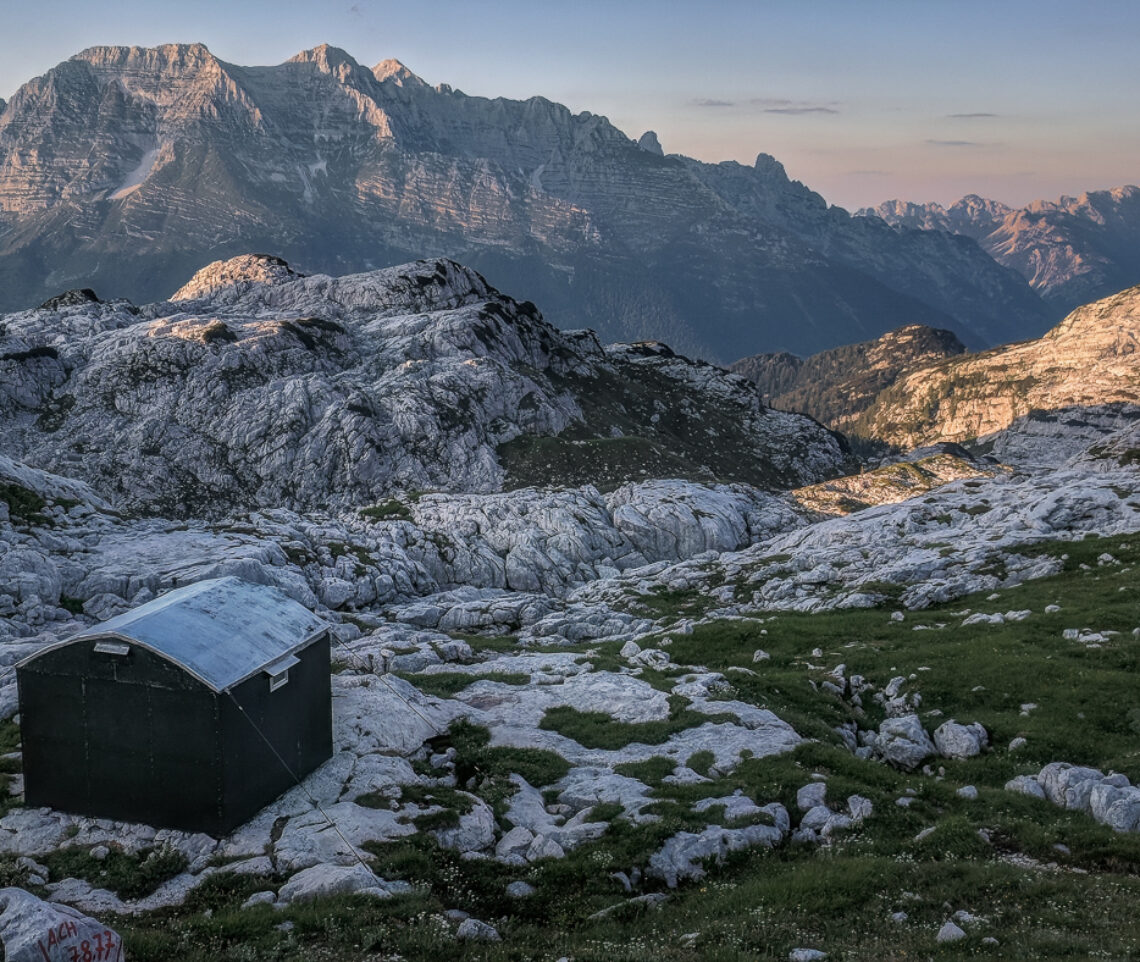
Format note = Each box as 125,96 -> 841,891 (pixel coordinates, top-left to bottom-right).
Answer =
17,578 -> 332,835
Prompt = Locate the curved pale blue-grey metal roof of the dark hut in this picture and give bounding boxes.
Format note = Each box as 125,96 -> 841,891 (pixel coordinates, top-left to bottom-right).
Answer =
65,578 -> 328,692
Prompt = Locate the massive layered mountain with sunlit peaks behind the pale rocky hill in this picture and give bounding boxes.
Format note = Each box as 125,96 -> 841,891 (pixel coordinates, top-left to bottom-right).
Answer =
0,44 -> 1055,360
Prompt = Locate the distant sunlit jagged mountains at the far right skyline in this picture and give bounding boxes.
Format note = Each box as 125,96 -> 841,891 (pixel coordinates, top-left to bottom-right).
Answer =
857,186 -> 1140,312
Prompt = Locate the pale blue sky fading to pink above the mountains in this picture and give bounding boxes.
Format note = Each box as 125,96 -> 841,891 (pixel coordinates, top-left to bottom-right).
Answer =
0,0 -> 1140,209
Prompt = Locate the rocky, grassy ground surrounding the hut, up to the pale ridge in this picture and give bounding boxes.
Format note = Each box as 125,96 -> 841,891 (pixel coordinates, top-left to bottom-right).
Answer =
0,255 -> 1140,962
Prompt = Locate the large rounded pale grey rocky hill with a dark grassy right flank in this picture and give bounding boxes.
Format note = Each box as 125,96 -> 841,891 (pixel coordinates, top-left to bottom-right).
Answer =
0,255 -> 846,516
